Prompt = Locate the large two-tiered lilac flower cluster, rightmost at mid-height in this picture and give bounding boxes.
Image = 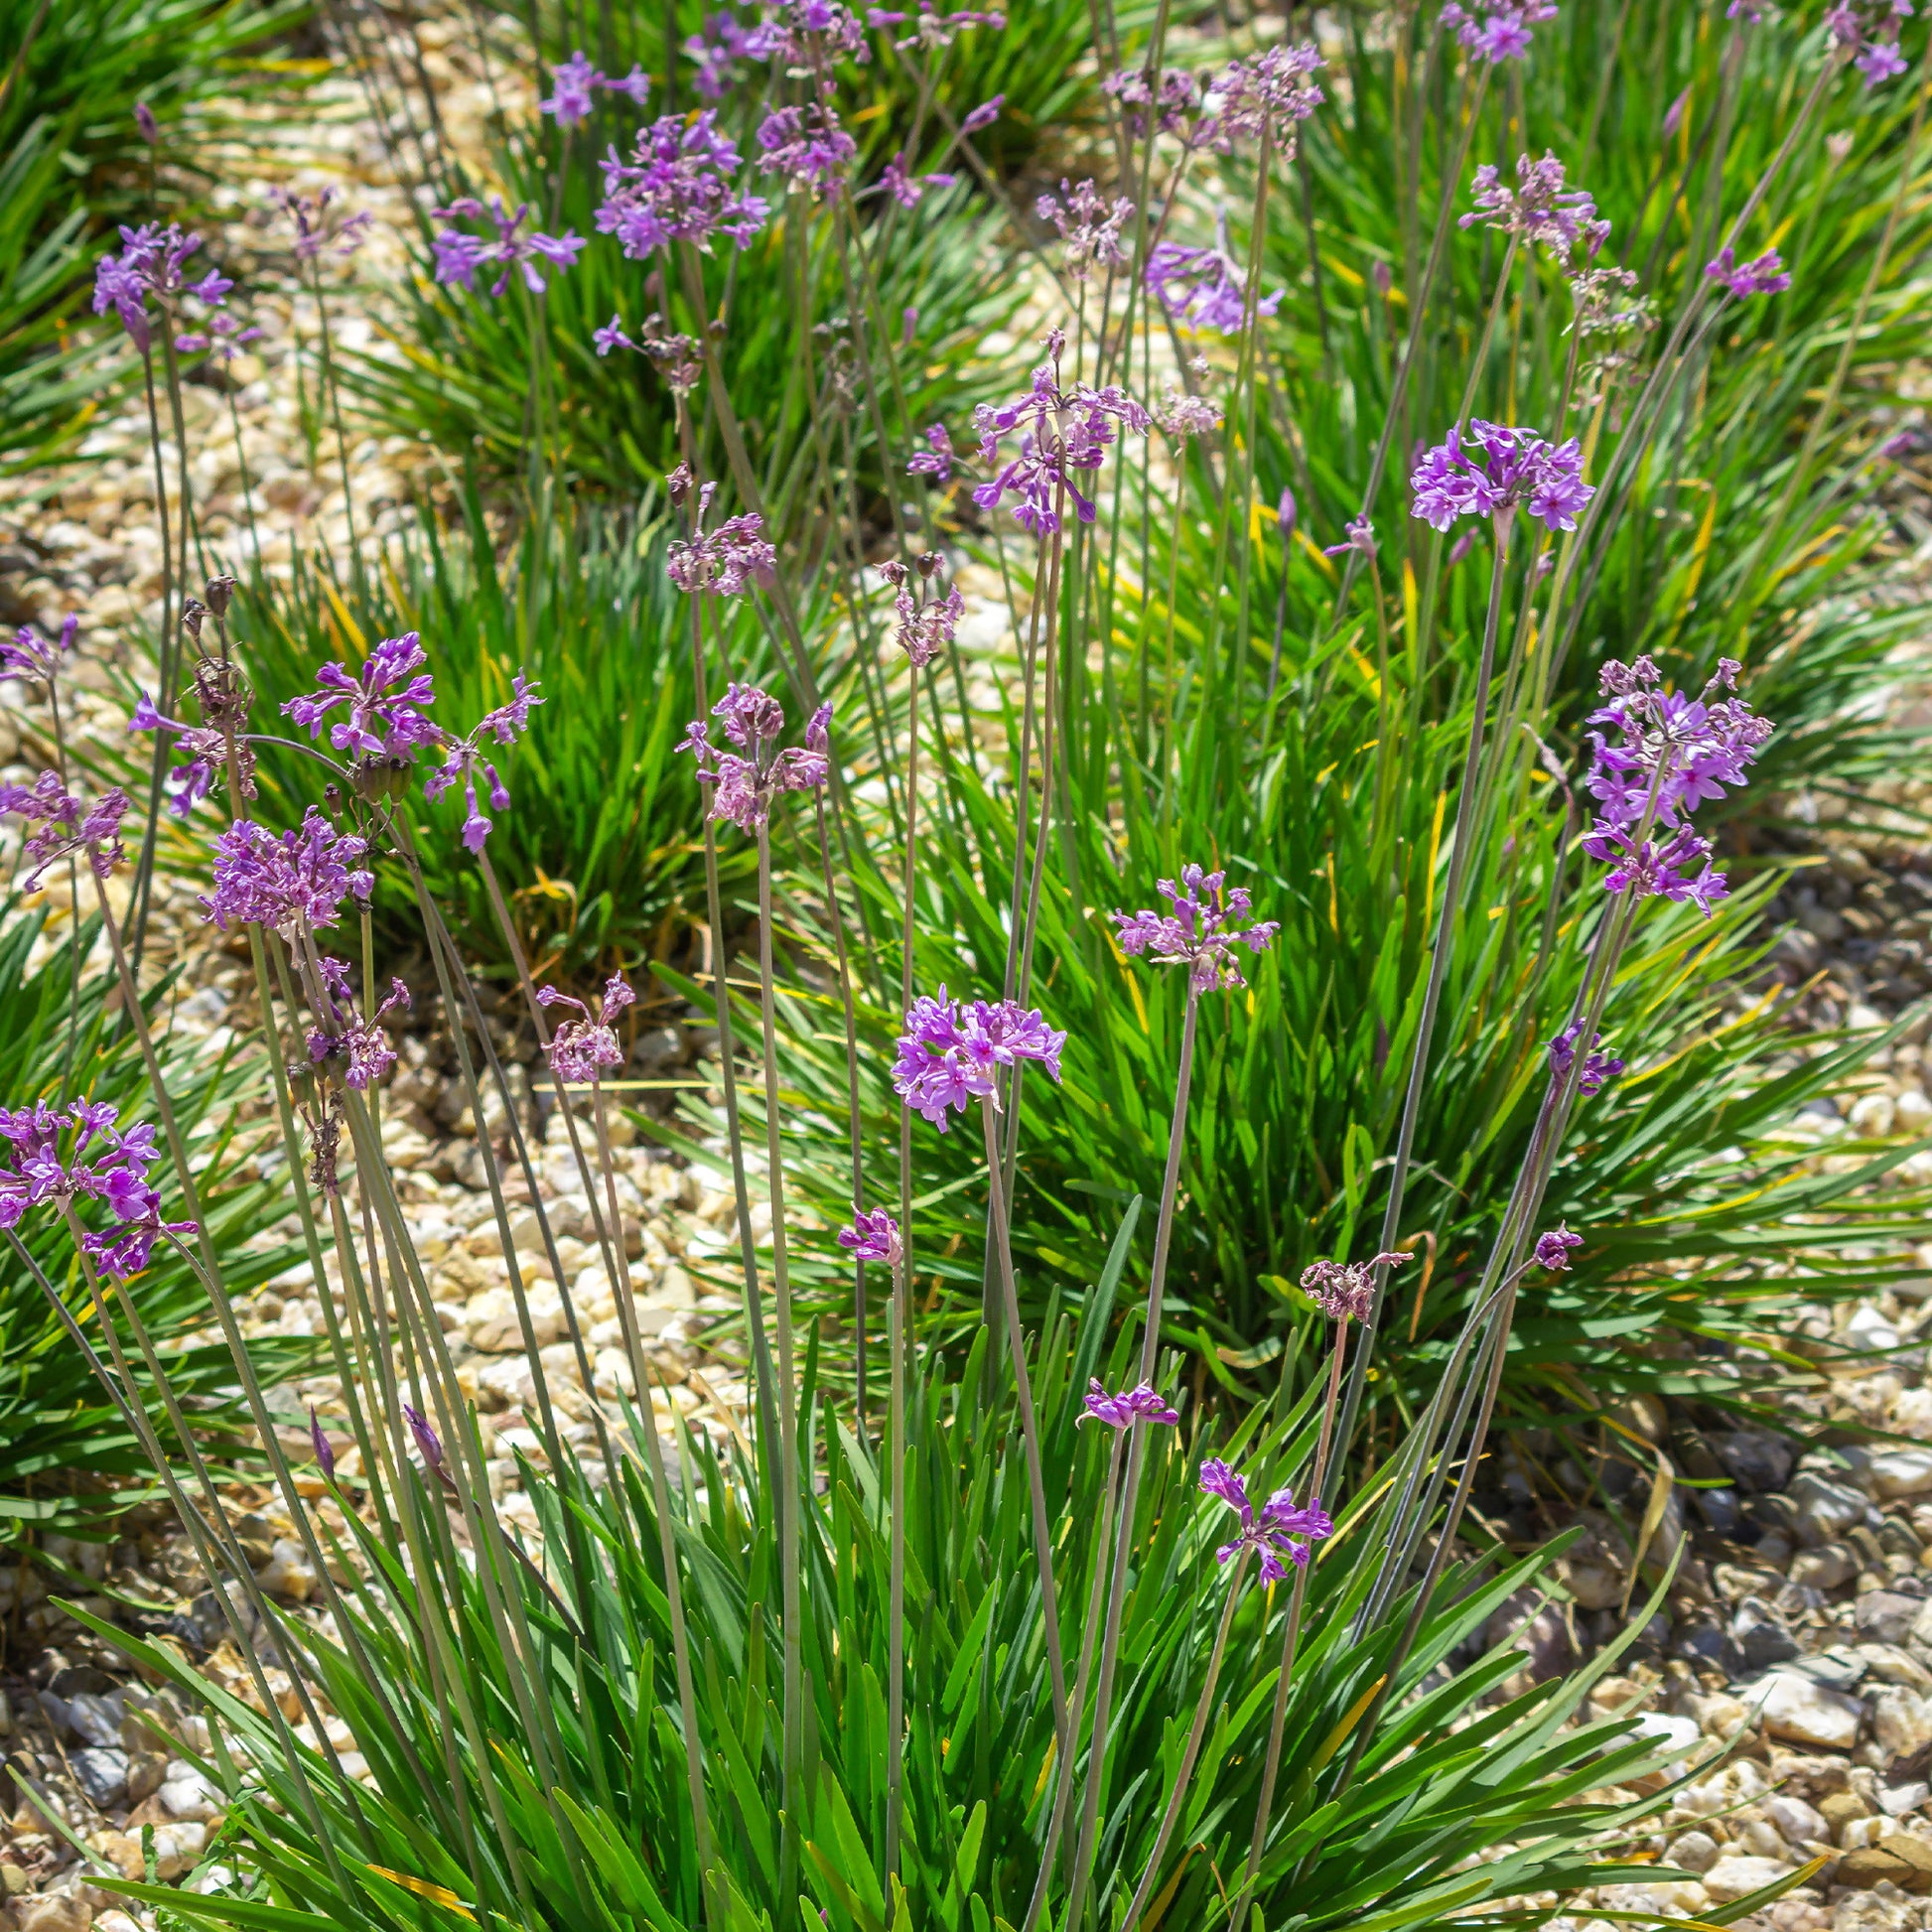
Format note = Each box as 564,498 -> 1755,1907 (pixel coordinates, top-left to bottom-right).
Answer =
1585,657 -> 1773,917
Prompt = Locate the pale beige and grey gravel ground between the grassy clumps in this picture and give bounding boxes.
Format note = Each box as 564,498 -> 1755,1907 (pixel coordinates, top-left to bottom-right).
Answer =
0,3 -> 1932,1932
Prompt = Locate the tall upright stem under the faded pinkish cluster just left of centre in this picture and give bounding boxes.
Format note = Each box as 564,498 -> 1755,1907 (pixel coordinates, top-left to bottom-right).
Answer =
758,817 -> 807,1893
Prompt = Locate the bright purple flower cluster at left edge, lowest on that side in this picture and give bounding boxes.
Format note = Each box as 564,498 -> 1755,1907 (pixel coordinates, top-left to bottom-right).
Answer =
0,1099 -> 196,1281
